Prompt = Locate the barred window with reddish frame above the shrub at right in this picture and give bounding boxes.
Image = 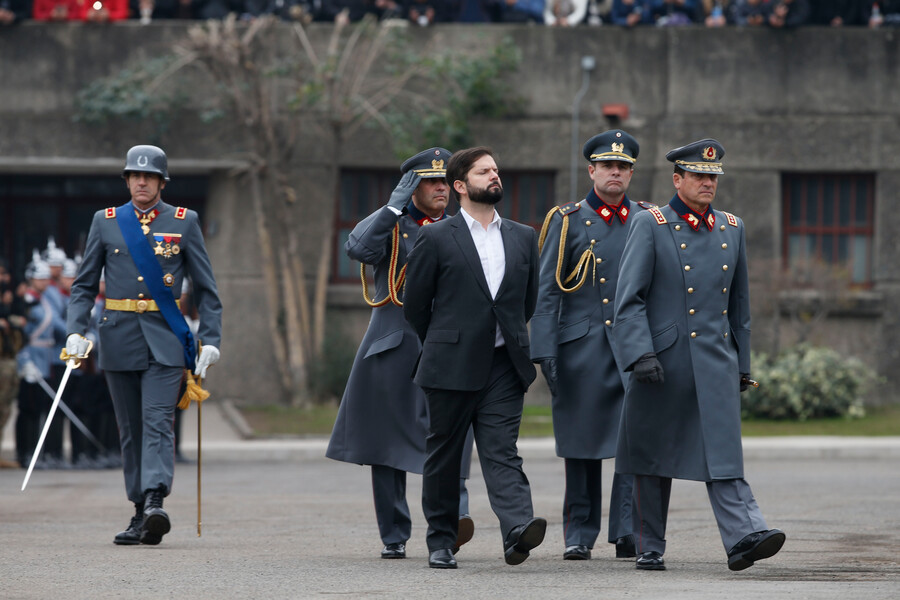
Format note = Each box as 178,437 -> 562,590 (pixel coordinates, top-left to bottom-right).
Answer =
782,173 -> 875,286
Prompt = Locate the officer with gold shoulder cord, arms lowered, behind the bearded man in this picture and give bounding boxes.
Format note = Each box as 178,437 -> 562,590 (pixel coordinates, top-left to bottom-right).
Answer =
531,129 -> 653,560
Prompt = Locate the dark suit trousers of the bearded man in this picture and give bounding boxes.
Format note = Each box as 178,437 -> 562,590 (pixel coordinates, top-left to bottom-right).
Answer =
422,347 -> 534,551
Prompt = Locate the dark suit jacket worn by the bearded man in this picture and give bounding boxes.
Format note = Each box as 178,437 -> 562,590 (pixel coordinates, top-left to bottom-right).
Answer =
403,213 -> 539,391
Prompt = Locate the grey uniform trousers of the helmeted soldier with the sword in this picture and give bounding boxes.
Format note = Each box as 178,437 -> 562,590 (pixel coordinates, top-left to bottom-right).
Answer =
105,359 -> 184,503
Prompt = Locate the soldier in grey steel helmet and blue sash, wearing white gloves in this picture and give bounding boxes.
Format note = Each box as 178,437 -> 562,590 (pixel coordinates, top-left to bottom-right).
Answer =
66,146 -> 222,545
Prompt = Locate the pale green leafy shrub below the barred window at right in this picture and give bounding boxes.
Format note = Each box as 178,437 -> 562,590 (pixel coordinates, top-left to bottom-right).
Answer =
741,345 -> 878,421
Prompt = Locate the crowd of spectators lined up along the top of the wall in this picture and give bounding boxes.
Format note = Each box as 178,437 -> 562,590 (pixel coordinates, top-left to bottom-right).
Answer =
0,0 -> 900,28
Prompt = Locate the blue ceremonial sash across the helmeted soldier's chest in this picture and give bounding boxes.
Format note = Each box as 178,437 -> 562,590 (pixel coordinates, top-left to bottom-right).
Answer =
116,202 -> 196,371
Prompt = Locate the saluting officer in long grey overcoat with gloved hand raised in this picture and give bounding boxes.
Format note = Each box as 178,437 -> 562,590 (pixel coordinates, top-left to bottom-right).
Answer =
325,148 -> 474,558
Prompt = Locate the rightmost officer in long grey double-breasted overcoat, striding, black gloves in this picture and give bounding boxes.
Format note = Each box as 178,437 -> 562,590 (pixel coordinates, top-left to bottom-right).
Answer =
613,139 -> 785,571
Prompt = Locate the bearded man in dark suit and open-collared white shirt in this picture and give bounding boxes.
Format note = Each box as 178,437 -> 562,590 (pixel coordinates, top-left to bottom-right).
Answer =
403,147 -> 547,569
